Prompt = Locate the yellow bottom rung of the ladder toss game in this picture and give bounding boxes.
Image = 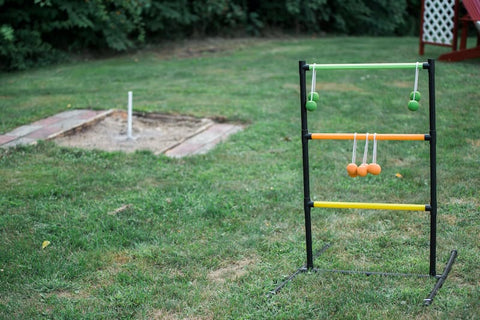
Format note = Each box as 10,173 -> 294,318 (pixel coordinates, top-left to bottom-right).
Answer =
313,201 -> 430,211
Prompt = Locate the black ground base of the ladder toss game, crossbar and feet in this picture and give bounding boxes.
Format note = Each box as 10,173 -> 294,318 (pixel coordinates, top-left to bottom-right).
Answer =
267,244 -> 457,306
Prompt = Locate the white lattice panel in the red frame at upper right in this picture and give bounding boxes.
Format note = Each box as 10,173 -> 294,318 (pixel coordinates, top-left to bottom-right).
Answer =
422,0 -> 455,45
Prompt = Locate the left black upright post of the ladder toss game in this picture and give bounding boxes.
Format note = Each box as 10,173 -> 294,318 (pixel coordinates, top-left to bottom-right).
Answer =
298,61 -> 313,269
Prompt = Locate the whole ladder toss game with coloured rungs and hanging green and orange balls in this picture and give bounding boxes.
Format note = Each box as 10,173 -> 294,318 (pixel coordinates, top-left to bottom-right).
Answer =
269,59 -> 457,305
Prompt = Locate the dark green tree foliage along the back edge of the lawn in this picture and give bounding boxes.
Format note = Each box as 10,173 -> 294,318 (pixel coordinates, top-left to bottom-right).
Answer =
0,0 -> 419,70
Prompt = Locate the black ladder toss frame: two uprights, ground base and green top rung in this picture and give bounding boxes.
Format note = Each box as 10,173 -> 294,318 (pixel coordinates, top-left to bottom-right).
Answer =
268,59 -> 457,306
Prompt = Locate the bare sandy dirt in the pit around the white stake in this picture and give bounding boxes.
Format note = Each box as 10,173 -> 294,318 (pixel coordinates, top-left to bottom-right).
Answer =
54,111 -> 214,154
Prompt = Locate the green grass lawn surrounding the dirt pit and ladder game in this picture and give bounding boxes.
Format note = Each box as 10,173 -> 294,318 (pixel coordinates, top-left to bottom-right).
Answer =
0,37 -> 480,319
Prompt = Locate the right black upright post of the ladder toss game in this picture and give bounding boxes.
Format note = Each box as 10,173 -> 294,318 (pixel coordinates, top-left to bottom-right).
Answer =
428,59 -> 437,276
